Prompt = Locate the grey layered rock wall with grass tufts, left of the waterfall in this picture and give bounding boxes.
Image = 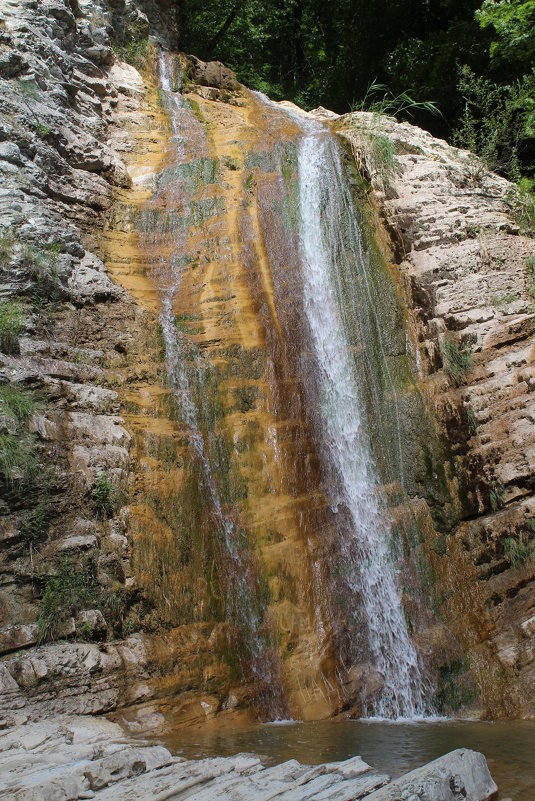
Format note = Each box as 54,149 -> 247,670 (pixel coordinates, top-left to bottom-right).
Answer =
0,0 -> 207,723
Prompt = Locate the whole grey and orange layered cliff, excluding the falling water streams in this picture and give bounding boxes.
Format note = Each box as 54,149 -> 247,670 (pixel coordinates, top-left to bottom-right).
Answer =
0,0 -> 535,730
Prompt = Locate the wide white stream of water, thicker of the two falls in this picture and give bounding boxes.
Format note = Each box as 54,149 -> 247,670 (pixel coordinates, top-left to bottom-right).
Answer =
298,109 -> 426,719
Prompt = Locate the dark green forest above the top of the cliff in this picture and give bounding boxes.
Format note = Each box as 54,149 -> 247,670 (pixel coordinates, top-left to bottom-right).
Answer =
179,0 -> 535,192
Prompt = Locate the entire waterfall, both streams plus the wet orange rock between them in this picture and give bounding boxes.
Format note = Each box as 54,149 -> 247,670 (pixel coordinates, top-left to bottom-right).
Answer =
136,53 -> 431,720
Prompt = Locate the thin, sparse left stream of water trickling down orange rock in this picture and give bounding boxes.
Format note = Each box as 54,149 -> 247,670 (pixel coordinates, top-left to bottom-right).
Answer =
153,52 -> 288,720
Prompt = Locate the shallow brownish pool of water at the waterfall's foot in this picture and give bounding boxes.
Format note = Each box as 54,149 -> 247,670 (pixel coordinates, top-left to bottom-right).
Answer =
165,721 -> 535,801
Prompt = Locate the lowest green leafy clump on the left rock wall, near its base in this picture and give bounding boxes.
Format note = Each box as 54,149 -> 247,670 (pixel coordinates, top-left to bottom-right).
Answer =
38,556 -> 99,643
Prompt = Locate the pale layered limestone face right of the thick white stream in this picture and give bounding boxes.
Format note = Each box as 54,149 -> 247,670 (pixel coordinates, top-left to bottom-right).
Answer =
340,112 -> 535,717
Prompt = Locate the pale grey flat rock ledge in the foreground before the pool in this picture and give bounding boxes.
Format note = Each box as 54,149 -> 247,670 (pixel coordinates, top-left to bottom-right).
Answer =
0,716 -> 497,801
